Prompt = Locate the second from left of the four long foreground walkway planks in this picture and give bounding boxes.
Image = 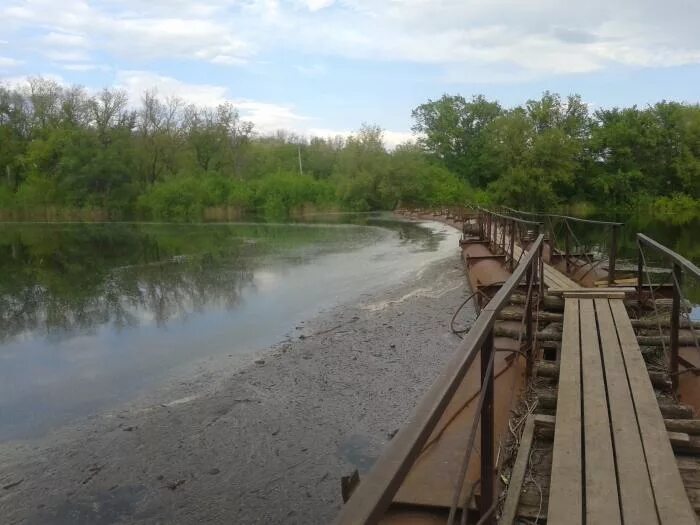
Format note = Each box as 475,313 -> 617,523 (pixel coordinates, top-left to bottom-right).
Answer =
579,299 -> 620,523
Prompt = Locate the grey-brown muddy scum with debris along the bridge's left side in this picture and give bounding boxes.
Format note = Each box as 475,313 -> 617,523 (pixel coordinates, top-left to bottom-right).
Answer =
0,231 -> 470,524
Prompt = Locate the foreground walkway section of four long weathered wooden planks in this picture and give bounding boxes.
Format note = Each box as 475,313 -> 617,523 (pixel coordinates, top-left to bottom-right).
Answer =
545,292 -> 696,525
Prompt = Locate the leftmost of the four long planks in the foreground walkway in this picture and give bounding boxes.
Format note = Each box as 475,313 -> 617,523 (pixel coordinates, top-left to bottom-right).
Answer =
547,299 -> 583,525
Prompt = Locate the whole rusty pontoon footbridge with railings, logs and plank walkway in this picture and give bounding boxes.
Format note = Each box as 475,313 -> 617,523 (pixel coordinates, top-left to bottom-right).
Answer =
336,207 -> 700,524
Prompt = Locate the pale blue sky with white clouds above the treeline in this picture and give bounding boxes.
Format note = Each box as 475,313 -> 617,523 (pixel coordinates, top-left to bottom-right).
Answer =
0,0 -> 700,145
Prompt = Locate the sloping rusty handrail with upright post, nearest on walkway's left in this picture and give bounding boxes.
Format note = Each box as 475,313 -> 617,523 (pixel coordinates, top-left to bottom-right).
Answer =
335,234 -> 544,525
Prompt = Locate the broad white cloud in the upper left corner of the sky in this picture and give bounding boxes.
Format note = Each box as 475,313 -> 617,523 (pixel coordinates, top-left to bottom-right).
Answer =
0,0 -> 252,64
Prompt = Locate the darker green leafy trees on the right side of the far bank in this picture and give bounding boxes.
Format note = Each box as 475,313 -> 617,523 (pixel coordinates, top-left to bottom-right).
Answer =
413,92 -> 700,214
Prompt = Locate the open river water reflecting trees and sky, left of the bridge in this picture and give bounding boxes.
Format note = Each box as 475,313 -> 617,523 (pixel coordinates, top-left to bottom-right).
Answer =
0,215 -> 459,440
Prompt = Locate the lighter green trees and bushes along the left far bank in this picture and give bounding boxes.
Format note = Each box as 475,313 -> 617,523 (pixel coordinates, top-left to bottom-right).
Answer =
0,78 -> 468,220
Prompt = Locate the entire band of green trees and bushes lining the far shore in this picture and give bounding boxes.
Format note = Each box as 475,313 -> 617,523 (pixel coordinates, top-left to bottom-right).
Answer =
0,78 -> 700,224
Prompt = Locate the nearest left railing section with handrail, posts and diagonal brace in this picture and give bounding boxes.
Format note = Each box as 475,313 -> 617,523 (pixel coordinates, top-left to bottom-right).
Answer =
336,232 -> 544,525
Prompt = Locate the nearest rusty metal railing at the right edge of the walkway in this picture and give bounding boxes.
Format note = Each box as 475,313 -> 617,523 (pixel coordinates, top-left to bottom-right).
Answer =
637,233 -> 700,392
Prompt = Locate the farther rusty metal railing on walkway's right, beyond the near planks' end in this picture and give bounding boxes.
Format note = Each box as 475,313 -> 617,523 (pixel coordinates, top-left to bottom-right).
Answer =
503,206 -> 624,286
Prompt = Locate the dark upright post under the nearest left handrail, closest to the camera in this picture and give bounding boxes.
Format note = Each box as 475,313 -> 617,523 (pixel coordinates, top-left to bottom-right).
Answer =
479,328 -> 495,525
